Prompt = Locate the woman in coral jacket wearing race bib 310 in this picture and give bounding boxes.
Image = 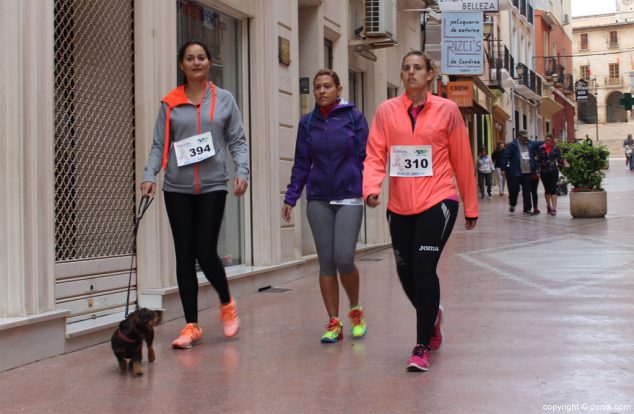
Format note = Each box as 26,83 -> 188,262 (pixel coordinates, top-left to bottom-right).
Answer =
363,51 -> 478,371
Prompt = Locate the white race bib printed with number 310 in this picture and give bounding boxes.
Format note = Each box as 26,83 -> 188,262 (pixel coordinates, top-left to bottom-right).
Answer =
390,145 -> 434,177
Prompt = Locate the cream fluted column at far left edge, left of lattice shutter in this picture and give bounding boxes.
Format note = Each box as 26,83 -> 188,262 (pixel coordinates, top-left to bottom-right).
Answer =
0,0 -> 55,316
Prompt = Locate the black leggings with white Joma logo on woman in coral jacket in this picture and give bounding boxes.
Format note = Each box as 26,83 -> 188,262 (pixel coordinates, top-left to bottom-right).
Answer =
387,200 -> 458,346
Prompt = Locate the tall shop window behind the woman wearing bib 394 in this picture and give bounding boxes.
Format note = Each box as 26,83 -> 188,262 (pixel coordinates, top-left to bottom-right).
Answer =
174,0 -> 245,266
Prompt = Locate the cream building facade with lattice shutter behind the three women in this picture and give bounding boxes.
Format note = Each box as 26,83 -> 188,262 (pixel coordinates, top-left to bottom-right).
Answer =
0,0 -> 424,369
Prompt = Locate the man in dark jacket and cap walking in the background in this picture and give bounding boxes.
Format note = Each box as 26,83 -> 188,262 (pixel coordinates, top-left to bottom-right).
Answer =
506,130 -> 541,215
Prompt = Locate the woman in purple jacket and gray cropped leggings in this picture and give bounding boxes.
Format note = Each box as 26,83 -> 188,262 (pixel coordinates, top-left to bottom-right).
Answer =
282,69 -> 368,343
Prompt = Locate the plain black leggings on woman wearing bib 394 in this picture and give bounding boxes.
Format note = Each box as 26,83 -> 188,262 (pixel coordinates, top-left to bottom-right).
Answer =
163,191 -> 231,323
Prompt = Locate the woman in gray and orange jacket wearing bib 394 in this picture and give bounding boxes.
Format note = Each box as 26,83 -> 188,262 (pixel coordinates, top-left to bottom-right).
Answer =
141,41 -> 249,349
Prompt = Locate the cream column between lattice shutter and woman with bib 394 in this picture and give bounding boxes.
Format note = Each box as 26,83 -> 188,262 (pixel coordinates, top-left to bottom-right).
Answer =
134,0 -> 176,292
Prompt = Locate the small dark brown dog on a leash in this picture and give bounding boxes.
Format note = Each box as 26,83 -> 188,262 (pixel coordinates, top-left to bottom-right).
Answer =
110,308 -> 163,376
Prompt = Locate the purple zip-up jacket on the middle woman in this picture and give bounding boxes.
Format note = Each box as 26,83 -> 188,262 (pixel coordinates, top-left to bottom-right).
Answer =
284,103 -> 368,207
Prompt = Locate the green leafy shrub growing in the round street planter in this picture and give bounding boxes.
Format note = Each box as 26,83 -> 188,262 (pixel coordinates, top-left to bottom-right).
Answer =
558,141 -> 610,191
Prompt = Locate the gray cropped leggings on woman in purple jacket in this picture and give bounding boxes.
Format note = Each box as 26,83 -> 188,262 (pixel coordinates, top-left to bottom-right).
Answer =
306,200 -> 363,276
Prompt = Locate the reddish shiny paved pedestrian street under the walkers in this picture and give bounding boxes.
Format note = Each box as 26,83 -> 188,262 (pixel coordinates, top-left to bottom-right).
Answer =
0,159 -> 634,414
